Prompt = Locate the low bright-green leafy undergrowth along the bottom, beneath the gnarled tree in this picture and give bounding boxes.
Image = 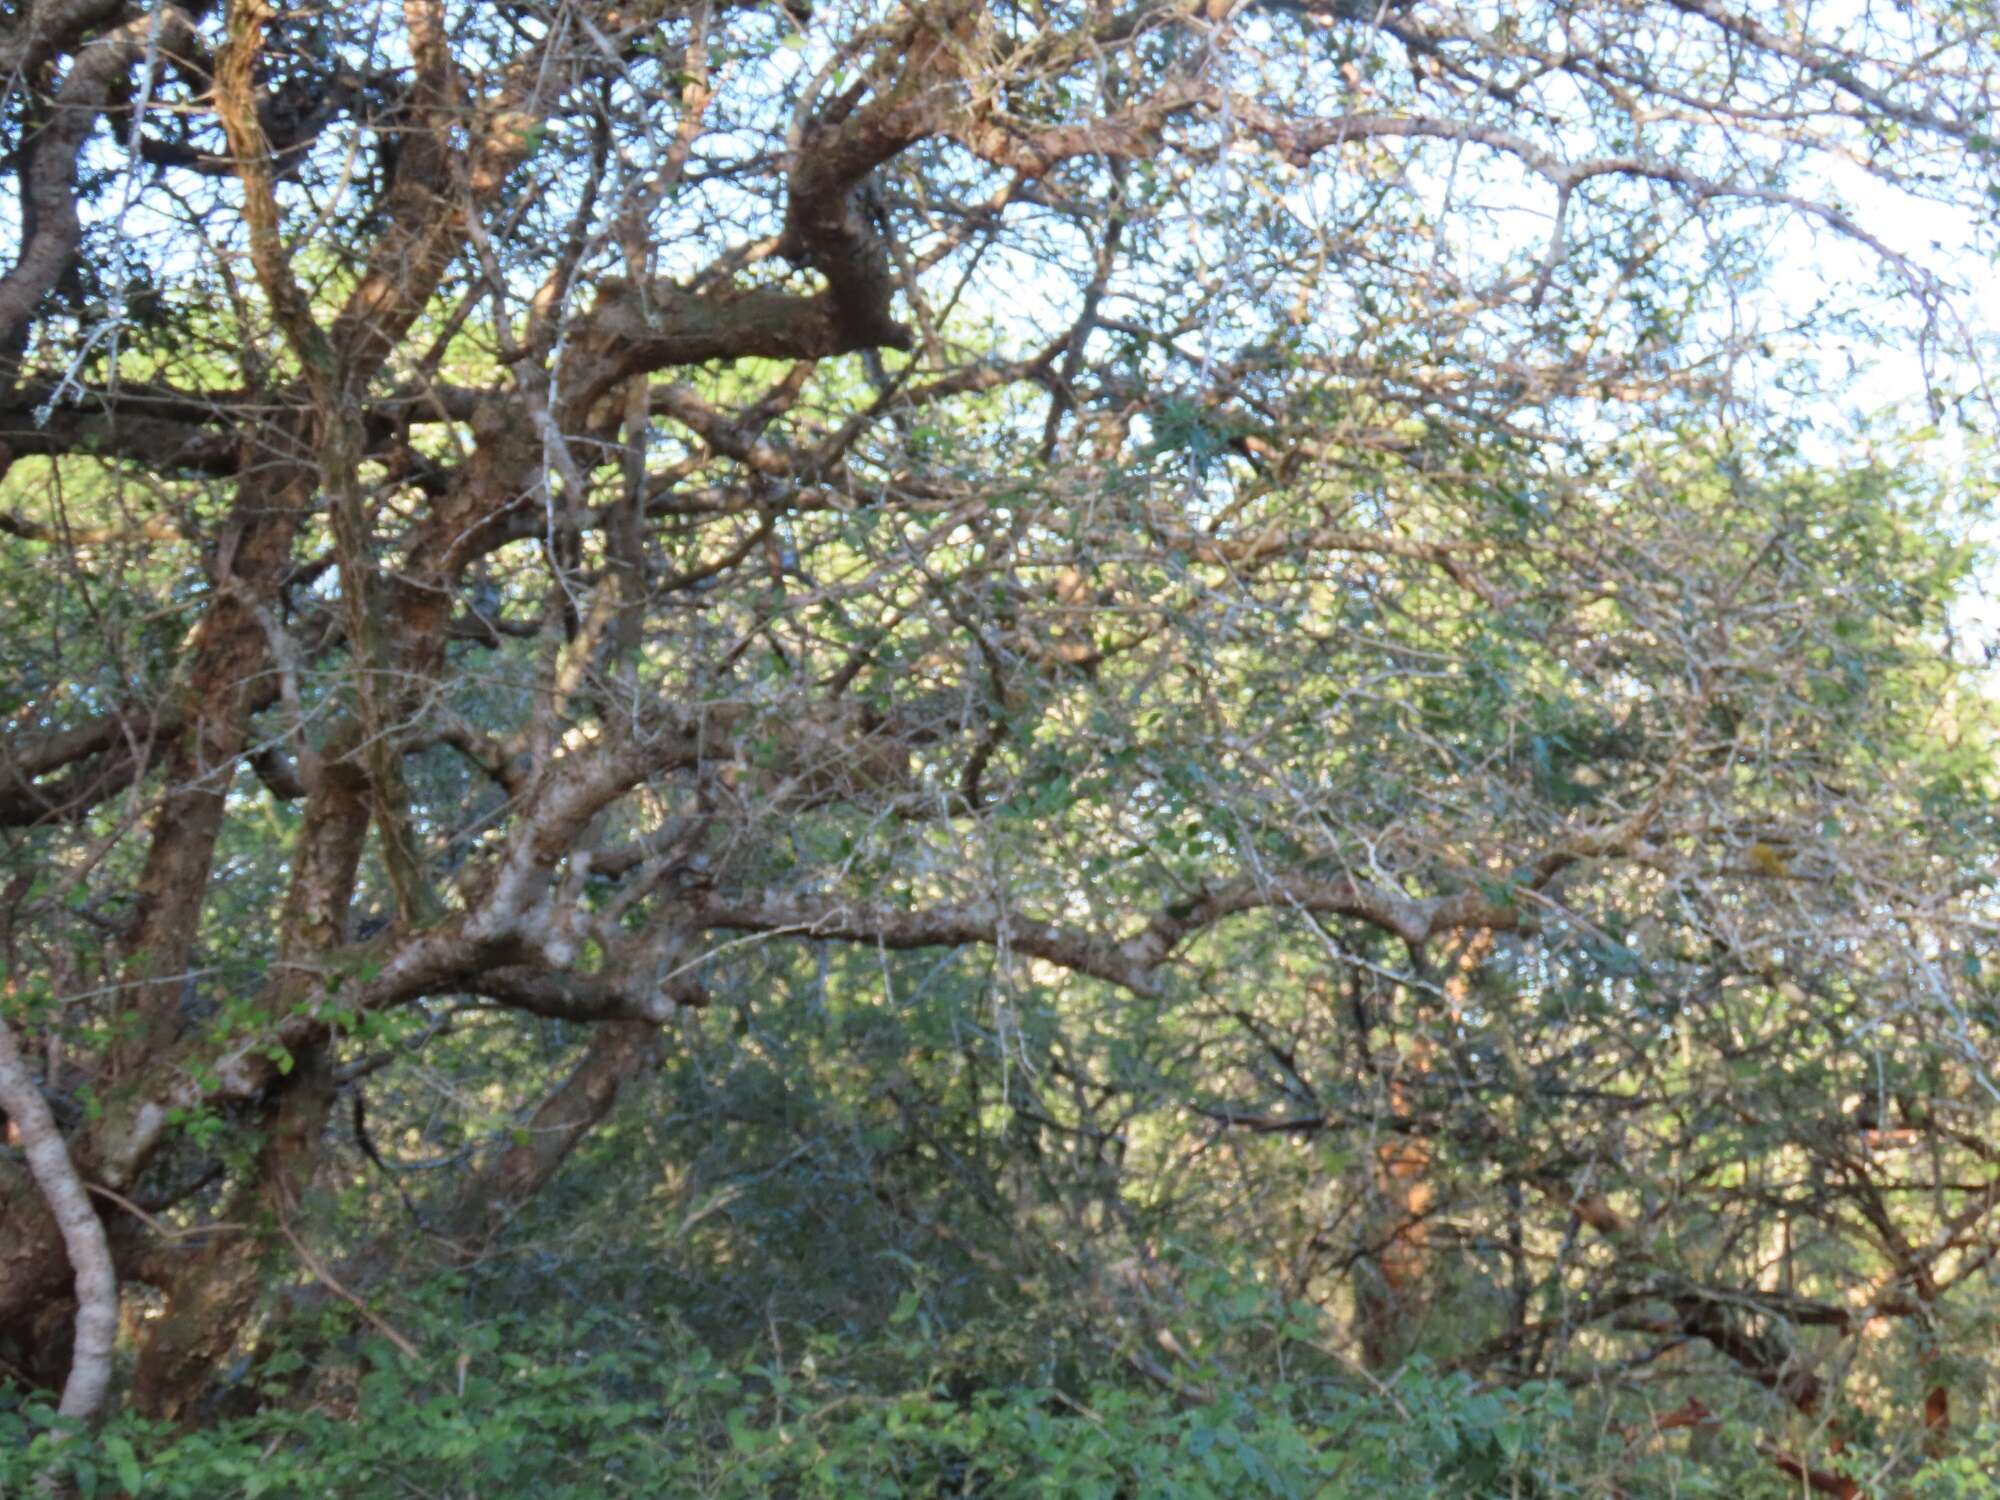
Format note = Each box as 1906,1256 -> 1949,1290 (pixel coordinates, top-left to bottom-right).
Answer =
0,1318 -> 1580,1500
